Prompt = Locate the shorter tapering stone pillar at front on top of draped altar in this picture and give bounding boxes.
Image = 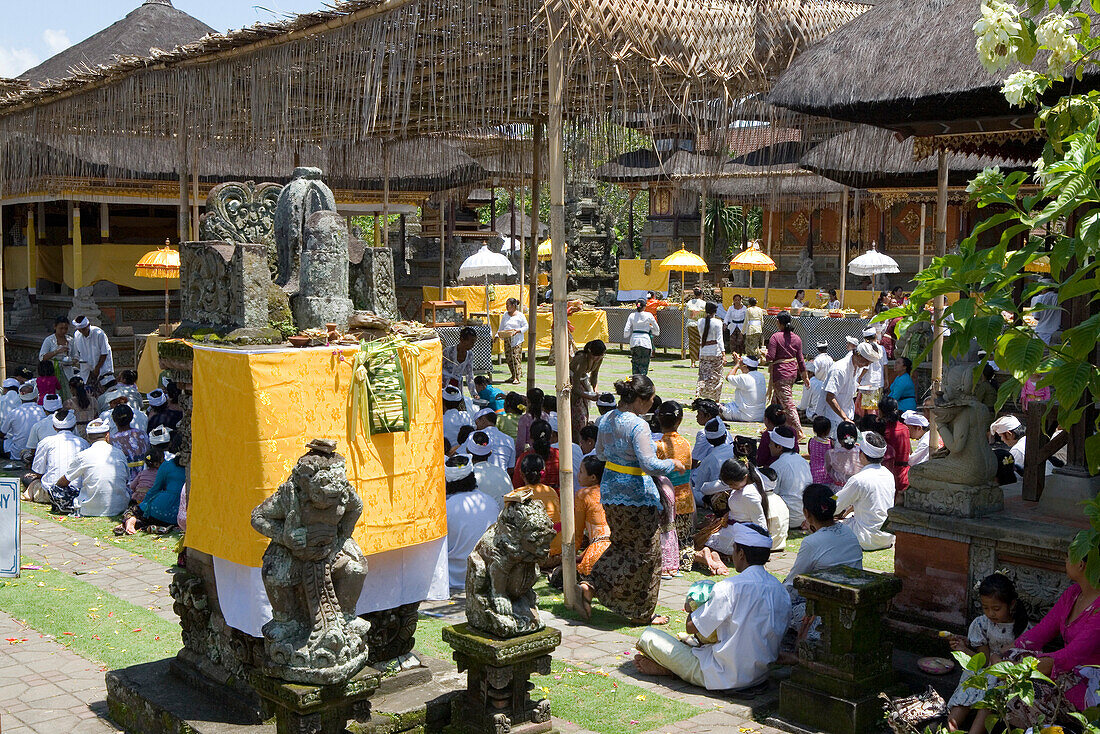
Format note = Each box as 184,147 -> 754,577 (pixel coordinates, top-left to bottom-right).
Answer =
290,211 -> 354,329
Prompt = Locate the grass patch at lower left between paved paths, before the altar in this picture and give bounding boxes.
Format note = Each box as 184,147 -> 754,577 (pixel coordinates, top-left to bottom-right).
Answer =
0,558 -> 183,669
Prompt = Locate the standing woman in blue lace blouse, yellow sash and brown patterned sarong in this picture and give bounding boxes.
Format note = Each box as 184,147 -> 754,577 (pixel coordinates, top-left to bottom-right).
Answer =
579,374 -> 686,624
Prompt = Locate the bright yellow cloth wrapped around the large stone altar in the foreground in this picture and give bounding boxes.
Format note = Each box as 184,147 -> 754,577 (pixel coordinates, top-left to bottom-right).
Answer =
184,341 -> 447,567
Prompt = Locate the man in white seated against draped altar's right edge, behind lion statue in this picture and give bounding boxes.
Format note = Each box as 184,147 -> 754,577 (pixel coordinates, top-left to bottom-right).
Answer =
443,454 -> 499,589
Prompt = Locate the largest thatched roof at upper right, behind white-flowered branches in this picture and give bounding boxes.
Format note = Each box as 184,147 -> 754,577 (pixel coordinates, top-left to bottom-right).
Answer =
768,0 -> 1095,135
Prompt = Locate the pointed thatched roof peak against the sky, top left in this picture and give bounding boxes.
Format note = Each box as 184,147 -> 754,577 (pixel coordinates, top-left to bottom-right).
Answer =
19,0 -> 217,83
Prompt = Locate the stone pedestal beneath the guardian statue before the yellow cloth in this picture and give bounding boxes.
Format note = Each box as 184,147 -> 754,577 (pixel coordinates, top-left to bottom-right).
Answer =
252,669 -> 380,734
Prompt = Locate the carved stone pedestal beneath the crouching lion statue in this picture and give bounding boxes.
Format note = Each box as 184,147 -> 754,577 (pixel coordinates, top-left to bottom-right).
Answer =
443,624 -> 561,734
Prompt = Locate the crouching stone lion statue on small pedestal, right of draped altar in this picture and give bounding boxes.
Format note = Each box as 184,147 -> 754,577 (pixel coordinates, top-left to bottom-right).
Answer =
466,491 -> 554,637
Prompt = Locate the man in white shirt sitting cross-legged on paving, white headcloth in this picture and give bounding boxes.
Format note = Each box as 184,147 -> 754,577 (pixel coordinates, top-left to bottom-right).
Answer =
634,523 -> 791,693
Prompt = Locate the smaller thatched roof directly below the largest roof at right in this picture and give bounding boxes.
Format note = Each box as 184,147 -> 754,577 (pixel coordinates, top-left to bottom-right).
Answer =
801,125 -> 1029,188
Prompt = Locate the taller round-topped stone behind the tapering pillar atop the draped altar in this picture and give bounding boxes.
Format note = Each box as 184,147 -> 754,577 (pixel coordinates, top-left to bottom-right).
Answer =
275,167 -> 334,290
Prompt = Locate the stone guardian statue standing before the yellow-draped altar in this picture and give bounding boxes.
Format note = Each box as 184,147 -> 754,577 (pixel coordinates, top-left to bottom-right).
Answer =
252,440 -> 370,686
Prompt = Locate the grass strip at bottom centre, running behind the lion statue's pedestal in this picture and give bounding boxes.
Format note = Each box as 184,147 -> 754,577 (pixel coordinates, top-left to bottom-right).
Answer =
416,616 -> 704,734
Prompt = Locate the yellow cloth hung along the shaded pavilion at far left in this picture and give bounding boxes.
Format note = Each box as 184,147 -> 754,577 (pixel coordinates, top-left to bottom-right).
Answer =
3,244 -> 179,293
